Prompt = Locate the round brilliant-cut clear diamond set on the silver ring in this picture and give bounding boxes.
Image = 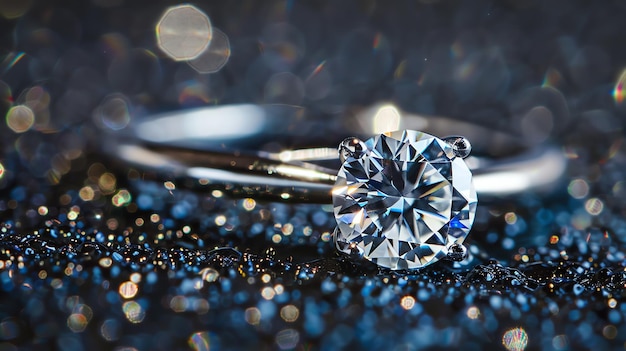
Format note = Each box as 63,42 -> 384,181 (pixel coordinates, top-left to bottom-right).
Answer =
333,130 -> 477,270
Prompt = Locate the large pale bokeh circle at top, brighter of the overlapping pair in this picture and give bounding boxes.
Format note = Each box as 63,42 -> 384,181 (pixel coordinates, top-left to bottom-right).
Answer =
156,5 -> 212,61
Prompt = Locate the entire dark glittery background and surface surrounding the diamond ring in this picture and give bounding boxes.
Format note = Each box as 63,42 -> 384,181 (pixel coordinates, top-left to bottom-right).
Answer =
0,0 -> 626,350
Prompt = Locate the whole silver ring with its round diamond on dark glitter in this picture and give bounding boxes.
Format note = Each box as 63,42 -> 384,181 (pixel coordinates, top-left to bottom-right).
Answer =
104,105 -> 565,270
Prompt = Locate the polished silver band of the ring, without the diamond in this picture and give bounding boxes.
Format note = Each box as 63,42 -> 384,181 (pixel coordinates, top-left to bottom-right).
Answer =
105,104 -> 566,203
